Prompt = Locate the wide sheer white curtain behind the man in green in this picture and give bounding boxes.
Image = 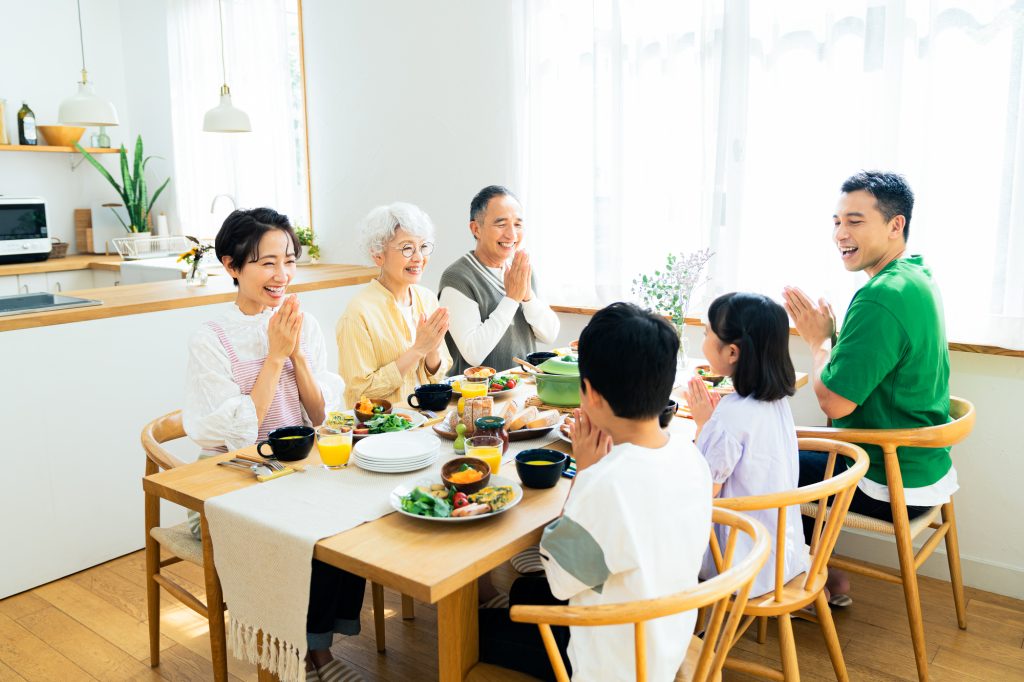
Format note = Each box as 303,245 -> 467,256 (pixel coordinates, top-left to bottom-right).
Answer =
523,0 -> 1024,348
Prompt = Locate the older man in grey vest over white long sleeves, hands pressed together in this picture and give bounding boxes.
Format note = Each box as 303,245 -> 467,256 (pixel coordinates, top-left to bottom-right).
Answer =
439,185 -> 558,375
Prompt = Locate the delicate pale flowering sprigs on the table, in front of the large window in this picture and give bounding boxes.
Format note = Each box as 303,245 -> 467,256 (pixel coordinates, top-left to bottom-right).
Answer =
633,249 -> 715,367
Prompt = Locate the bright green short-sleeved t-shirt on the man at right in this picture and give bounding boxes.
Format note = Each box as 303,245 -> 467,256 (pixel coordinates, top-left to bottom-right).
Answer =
821,256 -> 952,487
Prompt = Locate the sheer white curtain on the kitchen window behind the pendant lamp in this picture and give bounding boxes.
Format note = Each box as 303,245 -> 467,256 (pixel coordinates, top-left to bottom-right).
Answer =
168,0 -> 309,237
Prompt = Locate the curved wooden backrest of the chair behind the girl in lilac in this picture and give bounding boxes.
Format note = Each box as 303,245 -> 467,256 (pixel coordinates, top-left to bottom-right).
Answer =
712,438 -> 868,602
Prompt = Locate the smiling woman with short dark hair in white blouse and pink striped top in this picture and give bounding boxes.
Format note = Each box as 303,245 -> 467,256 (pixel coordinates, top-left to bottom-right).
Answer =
182,208 -> 366,672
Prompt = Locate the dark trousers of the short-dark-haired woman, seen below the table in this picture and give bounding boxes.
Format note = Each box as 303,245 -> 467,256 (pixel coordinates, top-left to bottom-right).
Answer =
306,559 -> 367,649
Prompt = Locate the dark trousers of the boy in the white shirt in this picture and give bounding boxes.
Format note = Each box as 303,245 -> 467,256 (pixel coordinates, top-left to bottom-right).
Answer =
479,576 -> 572,680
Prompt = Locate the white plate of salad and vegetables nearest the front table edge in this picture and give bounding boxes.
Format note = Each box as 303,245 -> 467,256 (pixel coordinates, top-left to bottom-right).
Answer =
390,476 -> 522,523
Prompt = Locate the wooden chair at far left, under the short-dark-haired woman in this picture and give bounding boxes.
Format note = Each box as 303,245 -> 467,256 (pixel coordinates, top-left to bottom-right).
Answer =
142,410 -> 395,682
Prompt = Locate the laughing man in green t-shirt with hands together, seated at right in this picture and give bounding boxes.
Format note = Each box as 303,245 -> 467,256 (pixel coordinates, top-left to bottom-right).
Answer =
783,171 -> 957,605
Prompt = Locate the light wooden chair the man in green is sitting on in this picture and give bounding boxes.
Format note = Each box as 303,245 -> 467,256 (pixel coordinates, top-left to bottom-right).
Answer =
797,396 -> 975,680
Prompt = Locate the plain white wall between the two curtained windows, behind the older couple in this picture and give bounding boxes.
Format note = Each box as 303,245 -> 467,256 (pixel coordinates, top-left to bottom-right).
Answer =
302,0 -> 518,286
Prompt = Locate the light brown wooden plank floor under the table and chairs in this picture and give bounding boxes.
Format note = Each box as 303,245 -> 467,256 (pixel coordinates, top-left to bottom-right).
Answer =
0,552 -> 1024,682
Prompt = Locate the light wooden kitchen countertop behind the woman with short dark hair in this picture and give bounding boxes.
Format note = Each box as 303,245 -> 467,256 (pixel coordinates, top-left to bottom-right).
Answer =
0,256 -> 379,332
